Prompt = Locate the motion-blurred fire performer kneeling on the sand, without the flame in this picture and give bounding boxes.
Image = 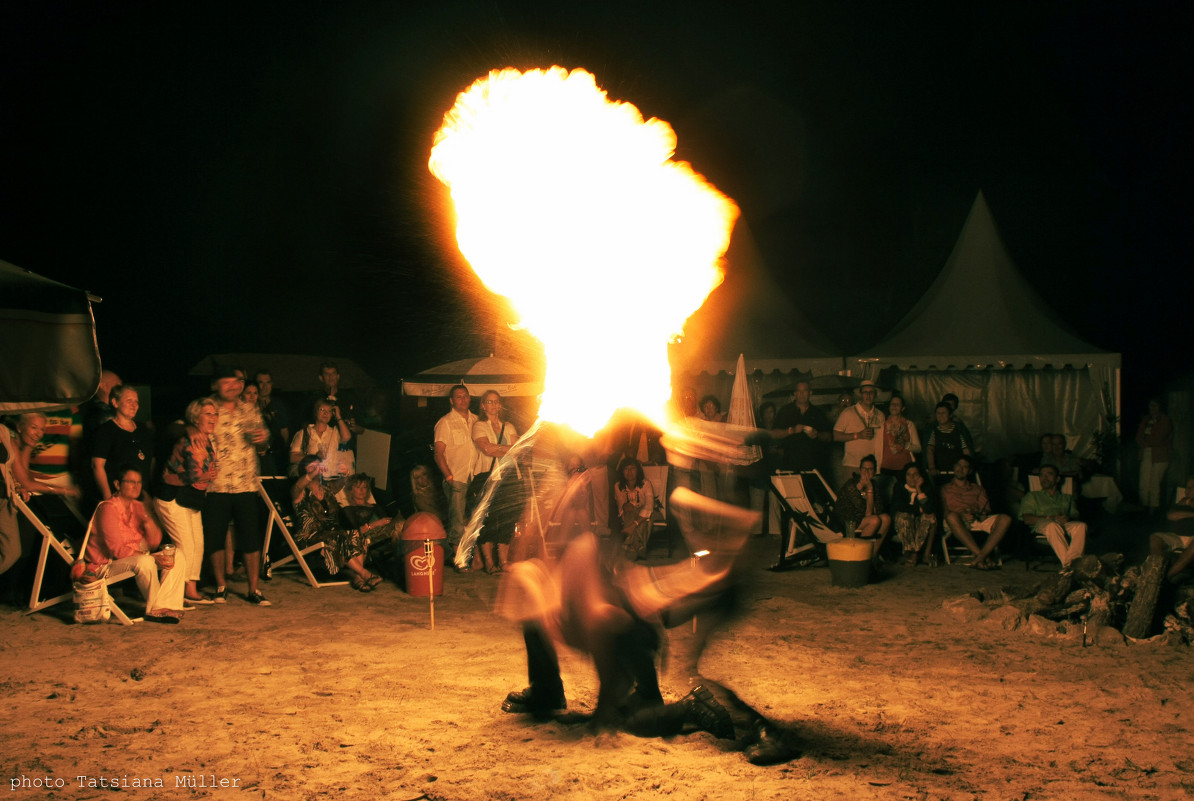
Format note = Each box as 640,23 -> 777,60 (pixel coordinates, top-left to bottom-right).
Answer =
479,432 -> 795,764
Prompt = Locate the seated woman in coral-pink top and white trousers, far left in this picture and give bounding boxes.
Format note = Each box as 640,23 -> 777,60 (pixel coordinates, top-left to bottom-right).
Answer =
84,466 -> 186,623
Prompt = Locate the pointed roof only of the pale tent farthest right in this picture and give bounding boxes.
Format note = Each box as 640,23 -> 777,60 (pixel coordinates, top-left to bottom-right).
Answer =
850,191 -> 1120,369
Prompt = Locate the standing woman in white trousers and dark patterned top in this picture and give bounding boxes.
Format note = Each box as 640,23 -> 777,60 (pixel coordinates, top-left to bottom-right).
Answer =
154,398 -> 219,604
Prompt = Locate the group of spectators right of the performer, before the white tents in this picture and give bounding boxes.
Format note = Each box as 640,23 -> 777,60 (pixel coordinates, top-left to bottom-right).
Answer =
757,381 -> 1184,571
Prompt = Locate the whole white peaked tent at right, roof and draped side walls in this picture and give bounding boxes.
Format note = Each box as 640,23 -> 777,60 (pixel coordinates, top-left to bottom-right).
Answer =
849,192 -> 1120,455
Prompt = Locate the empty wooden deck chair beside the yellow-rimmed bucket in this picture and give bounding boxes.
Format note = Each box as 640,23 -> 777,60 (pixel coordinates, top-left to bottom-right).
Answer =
770,470 -> 842,568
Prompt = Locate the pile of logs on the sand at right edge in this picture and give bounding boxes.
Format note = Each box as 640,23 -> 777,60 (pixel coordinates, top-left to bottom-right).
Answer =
946,554 -> 1194,645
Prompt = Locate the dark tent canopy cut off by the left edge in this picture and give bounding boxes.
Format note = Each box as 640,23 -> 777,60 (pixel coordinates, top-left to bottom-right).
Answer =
0,260 -> 100,412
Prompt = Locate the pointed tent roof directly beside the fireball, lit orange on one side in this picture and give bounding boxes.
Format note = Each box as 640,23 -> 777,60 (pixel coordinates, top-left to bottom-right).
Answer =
671,220 -> 843,375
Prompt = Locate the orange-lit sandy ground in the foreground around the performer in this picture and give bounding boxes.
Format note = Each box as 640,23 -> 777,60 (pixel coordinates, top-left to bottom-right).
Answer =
0,538 -> 1194,801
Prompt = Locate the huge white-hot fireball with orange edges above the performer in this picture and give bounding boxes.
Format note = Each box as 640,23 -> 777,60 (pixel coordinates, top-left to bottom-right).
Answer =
429,67 -> 738,435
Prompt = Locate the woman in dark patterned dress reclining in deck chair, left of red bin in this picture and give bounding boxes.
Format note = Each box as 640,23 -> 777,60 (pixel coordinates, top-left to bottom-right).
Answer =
290,456 -> 381,592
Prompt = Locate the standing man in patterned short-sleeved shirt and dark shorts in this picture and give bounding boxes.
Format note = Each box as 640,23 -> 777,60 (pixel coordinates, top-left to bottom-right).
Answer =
203,369 -> 270,606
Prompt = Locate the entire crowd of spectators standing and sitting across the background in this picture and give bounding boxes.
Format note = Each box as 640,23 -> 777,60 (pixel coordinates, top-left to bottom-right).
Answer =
0,364 -> 1194,620
